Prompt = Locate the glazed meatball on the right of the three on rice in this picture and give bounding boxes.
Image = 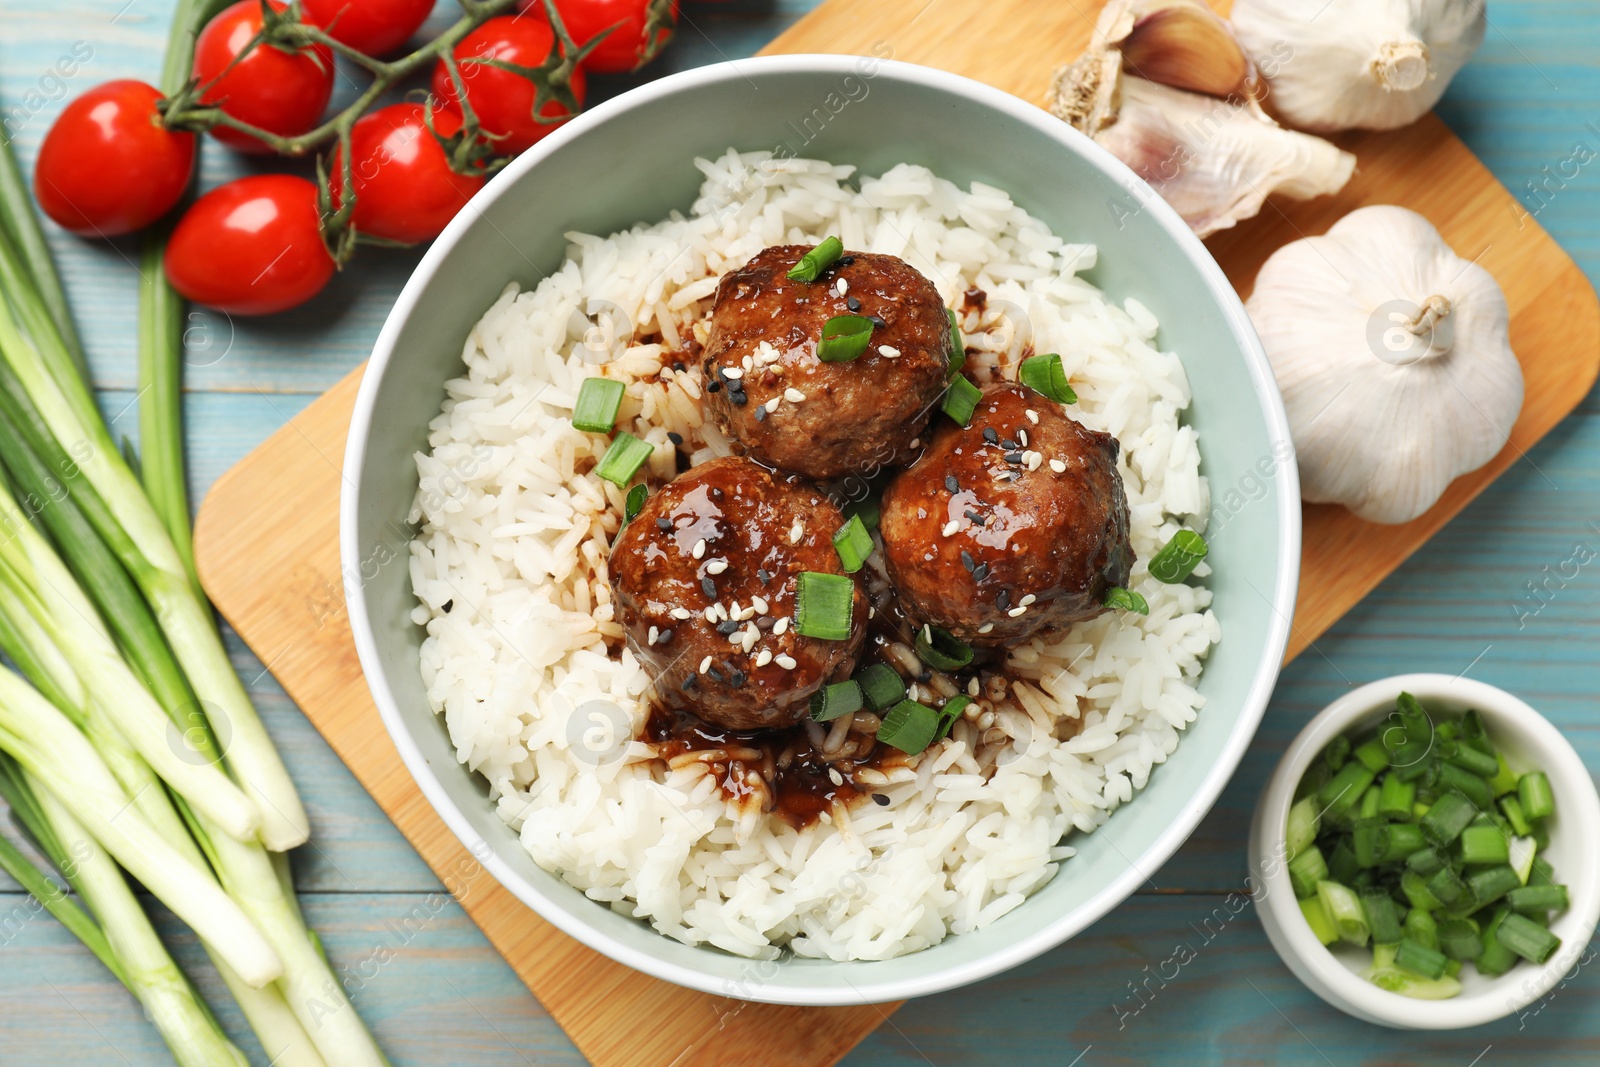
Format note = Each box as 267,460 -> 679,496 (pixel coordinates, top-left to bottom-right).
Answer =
880,382 -> 1134,648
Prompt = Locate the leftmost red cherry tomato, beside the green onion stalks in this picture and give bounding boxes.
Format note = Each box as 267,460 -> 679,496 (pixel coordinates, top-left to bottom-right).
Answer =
34,80 -> 195,237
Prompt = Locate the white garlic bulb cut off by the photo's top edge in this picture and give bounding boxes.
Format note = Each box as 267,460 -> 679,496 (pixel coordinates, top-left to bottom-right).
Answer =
1232,0 -> 1488,133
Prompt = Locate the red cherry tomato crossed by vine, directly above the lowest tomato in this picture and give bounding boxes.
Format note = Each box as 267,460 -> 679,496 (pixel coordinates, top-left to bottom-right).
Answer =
194,0 -> 333,152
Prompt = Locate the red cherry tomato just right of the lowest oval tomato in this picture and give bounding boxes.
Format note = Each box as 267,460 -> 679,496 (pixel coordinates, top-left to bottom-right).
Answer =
330,104 -> 483,242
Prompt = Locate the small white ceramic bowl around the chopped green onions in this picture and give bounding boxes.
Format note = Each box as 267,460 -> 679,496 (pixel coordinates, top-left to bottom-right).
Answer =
1250,673 -> 1600,1030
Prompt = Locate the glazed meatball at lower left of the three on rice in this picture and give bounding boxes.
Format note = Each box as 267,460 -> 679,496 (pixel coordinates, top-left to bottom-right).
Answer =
611,456 -> 867,729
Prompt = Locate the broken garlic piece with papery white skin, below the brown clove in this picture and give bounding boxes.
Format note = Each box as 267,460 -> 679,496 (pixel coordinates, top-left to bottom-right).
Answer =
1048,51 -> 1355,237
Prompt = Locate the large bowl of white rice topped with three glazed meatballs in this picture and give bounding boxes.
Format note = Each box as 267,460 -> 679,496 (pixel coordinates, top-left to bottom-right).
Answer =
341,56 -> 1299,1005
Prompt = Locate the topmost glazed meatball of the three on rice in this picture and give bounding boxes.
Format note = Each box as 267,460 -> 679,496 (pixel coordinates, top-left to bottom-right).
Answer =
704,245 -> 950,482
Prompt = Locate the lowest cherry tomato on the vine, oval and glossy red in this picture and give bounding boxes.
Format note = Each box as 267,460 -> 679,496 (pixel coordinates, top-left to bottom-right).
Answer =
166,174 -> 333,315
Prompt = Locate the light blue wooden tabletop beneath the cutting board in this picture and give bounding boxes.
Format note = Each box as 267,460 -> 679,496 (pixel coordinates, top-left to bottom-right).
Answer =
0,0 -> 1600,1067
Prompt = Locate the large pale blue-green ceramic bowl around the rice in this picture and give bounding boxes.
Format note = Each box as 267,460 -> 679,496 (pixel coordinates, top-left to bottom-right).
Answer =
341,56 -> 1301,1005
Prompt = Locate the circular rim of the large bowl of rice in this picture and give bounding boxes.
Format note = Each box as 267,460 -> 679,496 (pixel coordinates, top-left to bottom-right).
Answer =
339,54 -> 1301,1006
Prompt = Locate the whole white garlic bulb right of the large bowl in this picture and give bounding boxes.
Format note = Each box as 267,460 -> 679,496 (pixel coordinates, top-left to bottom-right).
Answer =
1245,206 -> 1523,523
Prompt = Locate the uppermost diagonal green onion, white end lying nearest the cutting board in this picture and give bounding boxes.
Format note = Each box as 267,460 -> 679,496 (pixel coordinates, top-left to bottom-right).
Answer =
0,227 -> 310,851
